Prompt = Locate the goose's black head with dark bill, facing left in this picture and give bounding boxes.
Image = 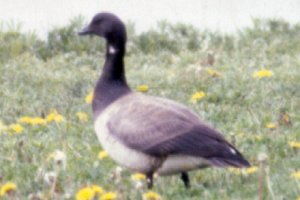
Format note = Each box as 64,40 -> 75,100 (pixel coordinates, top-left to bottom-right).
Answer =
78,13 -> 126,50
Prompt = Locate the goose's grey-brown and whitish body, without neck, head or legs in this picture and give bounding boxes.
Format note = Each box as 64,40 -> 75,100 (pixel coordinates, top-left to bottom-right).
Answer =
95,92 -> 248,175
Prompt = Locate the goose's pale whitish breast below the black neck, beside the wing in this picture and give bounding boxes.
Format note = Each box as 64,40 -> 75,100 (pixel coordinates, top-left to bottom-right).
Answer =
94,112 -> 162,173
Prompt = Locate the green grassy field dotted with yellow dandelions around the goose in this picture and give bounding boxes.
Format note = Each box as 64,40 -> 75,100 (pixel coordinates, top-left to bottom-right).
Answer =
0,19 -> 300,200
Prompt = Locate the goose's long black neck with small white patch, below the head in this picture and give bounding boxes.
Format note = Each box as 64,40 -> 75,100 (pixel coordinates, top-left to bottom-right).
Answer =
93,41 -> 131,118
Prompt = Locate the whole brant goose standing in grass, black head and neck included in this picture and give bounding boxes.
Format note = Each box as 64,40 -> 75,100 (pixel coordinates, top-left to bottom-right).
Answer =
78,13 -> 250,188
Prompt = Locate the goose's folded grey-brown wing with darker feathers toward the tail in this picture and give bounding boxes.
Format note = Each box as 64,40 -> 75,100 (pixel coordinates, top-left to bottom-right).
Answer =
107,95 -> 249,167
